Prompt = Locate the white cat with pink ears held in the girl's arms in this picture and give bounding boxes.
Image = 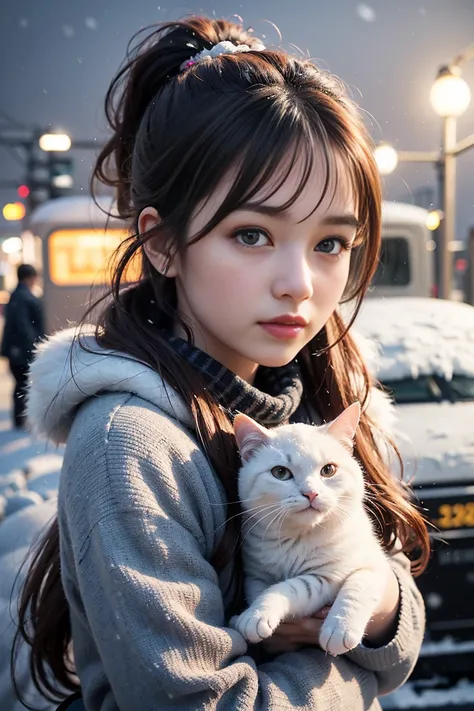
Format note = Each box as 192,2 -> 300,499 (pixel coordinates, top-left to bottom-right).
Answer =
230,403 -> 389,656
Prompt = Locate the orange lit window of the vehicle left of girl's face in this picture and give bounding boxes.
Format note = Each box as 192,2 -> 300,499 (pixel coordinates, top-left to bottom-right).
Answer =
48,229 -> 141,286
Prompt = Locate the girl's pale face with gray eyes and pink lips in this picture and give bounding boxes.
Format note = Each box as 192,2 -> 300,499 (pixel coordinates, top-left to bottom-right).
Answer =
148,152 -> 357,382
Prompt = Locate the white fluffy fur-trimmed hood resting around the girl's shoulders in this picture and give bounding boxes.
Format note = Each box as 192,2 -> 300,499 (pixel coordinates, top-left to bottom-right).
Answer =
27,326 -> 395,444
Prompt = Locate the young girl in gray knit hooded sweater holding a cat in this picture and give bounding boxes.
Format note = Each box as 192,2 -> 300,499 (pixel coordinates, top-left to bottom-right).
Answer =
14,18 -> 428,711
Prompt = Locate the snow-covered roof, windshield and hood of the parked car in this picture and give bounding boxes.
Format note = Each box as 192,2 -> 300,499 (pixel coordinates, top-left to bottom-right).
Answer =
356,298 -> 474,486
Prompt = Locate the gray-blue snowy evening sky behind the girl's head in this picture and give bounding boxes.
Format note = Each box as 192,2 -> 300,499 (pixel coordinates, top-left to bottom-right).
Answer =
0,0 -> 474,238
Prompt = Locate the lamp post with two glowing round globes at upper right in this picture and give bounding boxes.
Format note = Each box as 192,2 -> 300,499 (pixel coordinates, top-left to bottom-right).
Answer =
375,43 -> 474,299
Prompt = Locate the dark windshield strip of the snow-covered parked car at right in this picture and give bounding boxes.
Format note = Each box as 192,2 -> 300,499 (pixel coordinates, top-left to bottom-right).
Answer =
382,375 -> 474,405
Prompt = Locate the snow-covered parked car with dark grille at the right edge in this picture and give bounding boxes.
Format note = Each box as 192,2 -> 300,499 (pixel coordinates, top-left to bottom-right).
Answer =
355,298 -> 474,684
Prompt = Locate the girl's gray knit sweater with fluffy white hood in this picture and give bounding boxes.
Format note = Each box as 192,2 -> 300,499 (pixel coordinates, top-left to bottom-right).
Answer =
29,332 -> 424,711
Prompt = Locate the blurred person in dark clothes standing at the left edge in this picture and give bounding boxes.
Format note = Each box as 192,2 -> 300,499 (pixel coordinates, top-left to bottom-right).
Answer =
1,264 -> 45,427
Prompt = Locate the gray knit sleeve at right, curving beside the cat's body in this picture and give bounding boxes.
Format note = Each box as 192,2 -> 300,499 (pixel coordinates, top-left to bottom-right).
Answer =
347,553 -> 425,695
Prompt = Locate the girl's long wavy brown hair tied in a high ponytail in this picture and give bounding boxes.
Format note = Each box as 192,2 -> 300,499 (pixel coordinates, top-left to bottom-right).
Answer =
13,17 -> 429,699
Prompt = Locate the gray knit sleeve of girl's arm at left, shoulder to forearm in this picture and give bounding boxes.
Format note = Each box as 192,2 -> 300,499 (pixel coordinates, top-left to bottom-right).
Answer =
63,404 -> 378,711
